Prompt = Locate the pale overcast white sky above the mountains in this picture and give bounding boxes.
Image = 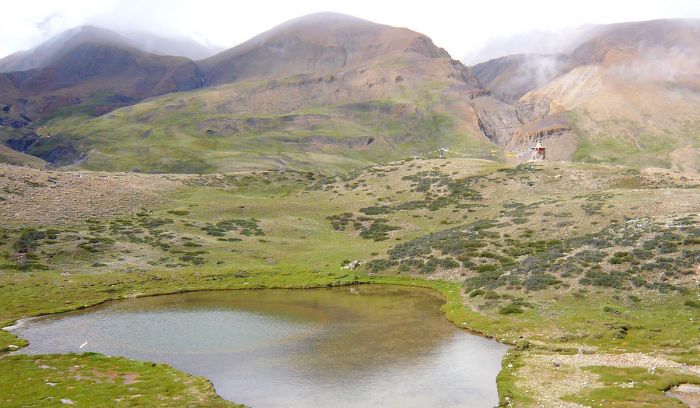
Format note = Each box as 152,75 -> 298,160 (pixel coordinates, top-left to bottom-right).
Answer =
0,0 -> 700,58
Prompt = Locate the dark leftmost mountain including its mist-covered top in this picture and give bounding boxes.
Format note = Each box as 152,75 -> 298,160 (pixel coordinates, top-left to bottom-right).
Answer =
0,26 -> 216,133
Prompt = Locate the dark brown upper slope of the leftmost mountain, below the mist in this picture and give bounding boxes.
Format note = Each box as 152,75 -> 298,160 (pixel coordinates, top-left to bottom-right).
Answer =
0,35 -> 203,120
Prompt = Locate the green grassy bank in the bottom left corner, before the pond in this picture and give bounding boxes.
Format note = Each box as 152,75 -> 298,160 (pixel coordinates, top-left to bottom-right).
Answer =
0,353 -> 242,407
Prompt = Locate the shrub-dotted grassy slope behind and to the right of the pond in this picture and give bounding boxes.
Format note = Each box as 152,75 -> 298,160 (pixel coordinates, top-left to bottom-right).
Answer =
0,159 -> 700,406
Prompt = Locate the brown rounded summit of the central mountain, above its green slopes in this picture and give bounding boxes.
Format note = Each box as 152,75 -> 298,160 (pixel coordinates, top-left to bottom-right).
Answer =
201,13 -> 450,85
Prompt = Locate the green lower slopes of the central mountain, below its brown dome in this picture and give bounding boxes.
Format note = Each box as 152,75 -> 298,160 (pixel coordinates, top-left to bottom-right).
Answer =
39,82 -> 500,173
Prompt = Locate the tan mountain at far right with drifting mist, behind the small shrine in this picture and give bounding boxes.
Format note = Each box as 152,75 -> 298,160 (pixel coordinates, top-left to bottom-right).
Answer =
472,20 -> 700,171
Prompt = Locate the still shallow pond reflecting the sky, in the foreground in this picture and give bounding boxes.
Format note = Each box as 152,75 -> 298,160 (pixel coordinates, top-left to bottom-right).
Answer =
14,285 -> 506,407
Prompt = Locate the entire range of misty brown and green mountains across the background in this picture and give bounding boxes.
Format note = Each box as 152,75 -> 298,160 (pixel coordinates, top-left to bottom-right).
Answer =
0,13 -> 700,173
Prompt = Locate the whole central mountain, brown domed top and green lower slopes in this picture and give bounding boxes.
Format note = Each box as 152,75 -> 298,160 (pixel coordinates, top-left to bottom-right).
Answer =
32,13 -> 498,172
